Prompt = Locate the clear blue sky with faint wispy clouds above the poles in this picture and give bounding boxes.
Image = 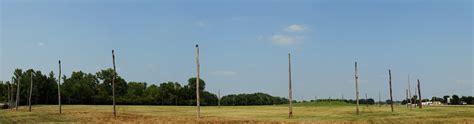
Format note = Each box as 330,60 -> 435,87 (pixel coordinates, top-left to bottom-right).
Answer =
0,0 -> 474,100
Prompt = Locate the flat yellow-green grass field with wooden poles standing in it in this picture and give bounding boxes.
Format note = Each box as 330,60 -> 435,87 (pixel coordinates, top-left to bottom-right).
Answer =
0,102 -> 474,123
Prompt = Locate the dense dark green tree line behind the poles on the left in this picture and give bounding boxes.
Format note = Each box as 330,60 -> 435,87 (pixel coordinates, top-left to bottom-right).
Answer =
0,68 -> 288,106
